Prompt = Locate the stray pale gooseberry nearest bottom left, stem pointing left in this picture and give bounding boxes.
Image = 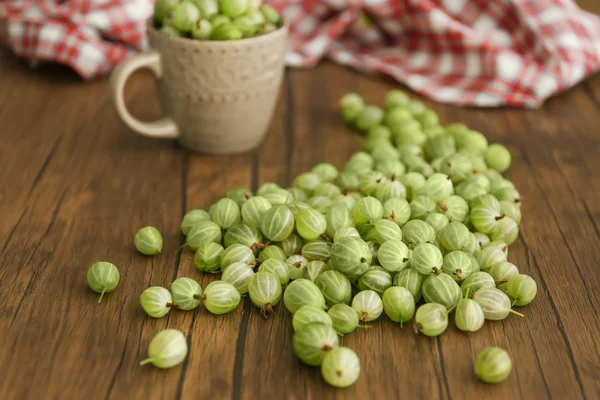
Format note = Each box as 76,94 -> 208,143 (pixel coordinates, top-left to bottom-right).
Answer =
140,329 -> 188,369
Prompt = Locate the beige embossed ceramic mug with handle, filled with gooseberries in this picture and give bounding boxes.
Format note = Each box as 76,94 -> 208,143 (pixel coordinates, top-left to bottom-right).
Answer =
110,22 -> 287,153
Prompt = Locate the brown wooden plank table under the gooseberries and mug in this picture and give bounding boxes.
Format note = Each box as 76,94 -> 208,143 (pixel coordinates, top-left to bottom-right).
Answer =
0,7 -> 600,399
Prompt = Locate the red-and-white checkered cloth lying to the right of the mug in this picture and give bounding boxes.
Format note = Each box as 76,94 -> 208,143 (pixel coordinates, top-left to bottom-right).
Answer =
272,0 -> 600,108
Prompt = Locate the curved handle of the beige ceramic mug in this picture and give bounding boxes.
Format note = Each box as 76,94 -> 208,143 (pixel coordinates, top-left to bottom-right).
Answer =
110,50 -> 179,139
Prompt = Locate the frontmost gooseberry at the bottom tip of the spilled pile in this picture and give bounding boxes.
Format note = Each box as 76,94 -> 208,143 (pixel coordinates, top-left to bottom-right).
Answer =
321,346 -> 360,388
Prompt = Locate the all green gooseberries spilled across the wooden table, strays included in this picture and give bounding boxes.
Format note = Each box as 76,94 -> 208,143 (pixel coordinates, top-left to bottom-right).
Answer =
88,90 -> 537,387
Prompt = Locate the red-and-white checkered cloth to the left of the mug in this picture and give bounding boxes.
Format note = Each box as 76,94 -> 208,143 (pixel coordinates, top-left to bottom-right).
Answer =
0,0 -> 153,79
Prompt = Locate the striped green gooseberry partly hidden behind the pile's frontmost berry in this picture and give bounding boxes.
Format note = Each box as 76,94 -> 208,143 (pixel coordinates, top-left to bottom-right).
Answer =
292,322 -> 339,366
